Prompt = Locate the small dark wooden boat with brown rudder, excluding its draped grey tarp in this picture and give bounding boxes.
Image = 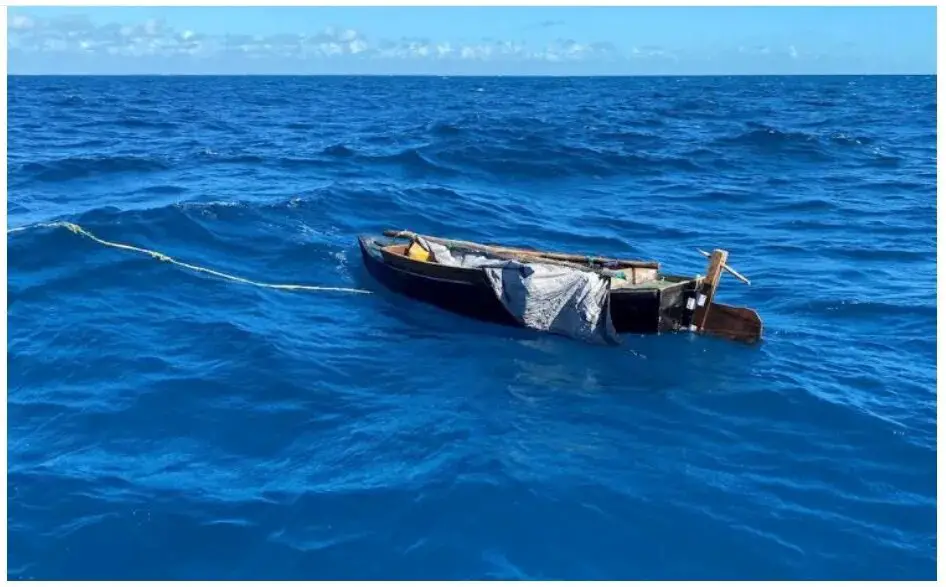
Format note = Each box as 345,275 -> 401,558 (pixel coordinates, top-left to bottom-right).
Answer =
359,230 -> 762,343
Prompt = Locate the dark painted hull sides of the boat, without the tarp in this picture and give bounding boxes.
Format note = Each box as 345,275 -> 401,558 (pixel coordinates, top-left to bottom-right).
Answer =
359,236 -> 698,334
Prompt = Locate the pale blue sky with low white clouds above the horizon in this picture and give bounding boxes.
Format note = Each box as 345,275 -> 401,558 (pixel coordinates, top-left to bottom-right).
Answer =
7,6 -> 936,75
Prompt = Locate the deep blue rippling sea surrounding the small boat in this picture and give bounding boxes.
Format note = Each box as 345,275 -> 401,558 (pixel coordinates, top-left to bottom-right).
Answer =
7,77 -> 936,579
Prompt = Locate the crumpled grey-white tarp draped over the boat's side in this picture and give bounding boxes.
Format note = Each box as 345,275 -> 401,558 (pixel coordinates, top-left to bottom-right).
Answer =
418,238 -> 620,344
